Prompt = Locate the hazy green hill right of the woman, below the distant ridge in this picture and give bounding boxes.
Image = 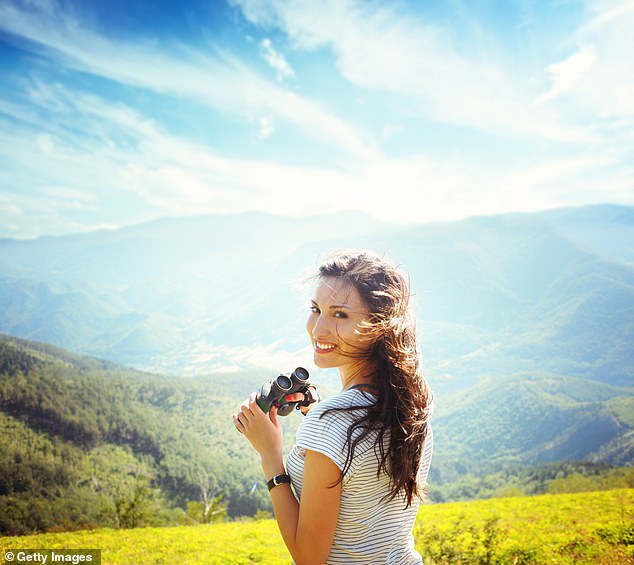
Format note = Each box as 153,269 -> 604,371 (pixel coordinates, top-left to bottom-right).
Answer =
434,374 -> 634,480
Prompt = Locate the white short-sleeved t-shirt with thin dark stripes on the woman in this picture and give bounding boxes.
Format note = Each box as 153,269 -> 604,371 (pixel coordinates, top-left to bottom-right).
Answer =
286,389 -> 433,565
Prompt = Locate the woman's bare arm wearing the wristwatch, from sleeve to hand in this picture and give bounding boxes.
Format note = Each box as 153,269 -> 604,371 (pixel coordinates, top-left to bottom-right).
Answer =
234,395 -> 341,565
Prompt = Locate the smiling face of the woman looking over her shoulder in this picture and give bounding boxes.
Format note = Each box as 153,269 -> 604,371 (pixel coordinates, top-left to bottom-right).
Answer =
306,277 -> 371,370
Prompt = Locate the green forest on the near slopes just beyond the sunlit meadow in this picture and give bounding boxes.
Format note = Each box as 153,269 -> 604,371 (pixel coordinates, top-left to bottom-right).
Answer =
0,337 -> 634,535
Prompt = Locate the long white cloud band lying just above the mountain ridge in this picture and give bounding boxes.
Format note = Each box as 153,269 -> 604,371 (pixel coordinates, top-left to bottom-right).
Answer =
0,76 -> 632,236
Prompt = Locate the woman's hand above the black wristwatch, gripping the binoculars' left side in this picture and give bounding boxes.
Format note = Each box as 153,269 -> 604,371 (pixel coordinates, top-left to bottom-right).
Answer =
233,392 -> 282,458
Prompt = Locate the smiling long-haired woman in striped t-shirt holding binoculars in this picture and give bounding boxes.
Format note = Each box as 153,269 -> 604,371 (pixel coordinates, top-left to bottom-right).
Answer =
233,252 -> 432,565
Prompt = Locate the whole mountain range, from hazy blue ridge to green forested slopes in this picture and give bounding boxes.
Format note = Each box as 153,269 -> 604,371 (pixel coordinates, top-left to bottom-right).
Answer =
0,205 -> 634,532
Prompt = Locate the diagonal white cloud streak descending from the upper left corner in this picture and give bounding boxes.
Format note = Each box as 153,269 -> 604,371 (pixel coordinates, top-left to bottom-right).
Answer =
0,2 -> 369,155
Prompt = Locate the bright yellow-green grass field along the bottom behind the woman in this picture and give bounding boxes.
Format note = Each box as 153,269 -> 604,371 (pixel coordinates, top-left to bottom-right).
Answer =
0,489 -> 634,565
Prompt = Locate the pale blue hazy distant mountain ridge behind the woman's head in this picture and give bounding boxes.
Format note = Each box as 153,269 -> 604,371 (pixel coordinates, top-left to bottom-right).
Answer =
0,205 -> 634,392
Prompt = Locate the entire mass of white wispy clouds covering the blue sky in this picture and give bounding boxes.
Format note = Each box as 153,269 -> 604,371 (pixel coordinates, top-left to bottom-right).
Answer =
0,0 -> 634,238
